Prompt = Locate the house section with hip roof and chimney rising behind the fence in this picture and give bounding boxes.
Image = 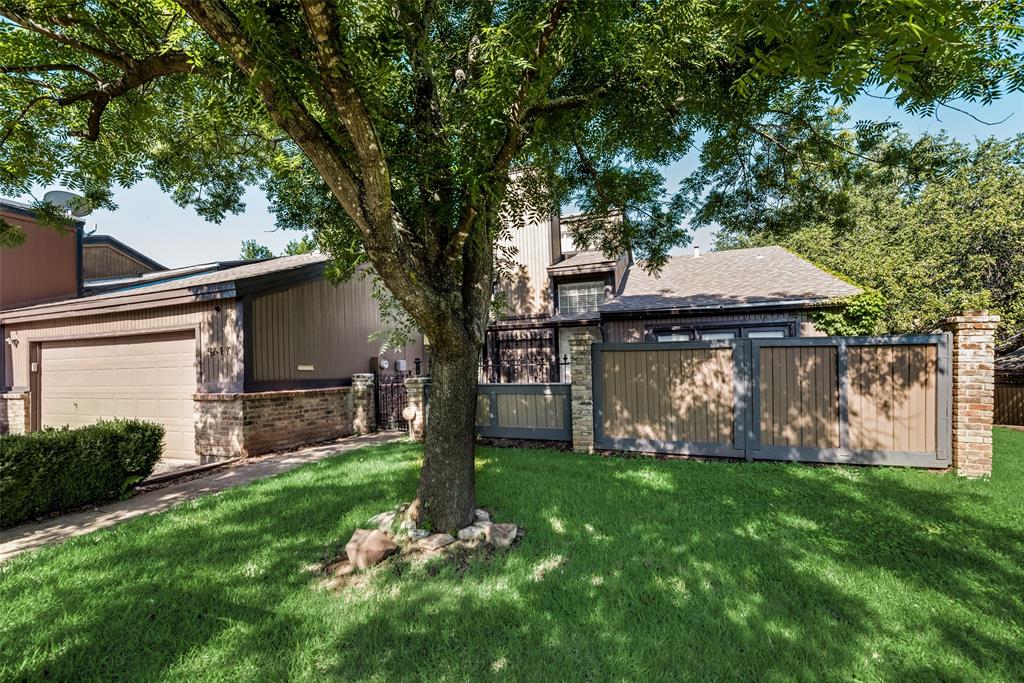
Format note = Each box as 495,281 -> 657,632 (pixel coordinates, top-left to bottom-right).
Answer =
491,211 -> 860,382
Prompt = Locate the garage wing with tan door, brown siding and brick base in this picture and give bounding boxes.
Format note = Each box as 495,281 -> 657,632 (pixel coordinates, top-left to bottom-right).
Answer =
0,254 -> 425,462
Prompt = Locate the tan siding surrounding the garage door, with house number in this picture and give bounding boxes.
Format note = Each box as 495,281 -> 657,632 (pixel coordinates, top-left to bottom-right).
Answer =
7,300 -> 243,391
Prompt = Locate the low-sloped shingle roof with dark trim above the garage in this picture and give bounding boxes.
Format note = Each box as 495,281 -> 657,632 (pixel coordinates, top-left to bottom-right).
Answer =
0,254 -> 328,324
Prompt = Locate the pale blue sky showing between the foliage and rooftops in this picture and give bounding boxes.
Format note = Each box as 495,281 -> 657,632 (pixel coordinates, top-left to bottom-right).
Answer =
20,93 -> 1024,267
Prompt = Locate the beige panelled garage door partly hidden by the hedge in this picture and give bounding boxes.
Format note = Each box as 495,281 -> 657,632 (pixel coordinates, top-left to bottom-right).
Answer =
39,332 -> 196,461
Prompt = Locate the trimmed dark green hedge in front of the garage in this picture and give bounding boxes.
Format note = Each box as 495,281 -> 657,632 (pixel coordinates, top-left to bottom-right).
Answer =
0,420 -> 164,528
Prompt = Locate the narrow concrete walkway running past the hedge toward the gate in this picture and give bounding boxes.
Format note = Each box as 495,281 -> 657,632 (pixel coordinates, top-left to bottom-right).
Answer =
0,432 -> 406,562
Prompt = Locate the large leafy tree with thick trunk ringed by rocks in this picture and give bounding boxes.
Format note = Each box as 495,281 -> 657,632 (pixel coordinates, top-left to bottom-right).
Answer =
0,0 -> 1024,529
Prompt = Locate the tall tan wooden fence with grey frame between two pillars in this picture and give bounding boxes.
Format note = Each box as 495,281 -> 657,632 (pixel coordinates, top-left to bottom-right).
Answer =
593,335 -> 951,467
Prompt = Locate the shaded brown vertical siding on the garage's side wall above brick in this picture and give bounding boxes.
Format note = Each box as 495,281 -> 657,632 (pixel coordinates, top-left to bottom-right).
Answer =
248,274 -> 424,382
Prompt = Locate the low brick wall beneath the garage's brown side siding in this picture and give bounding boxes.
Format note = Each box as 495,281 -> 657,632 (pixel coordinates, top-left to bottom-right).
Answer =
194,387 -> 352,460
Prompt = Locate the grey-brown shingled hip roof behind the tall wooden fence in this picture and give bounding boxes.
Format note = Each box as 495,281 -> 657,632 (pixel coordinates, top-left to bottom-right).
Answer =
600,247 -> 860,313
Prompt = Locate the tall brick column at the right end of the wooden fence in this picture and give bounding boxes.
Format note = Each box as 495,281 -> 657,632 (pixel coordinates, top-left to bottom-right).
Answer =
942,311 -> 999,477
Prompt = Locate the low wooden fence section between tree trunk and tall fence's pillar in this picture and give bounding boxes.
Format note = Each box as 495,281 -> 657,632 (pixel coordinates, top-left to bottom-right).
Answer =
476,384 -> 572,441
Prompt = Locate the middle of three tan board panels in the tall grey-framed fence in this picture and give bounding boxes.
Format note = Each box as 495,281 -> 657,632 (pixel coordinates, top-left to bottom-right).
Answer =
759,346 -> 839,449
